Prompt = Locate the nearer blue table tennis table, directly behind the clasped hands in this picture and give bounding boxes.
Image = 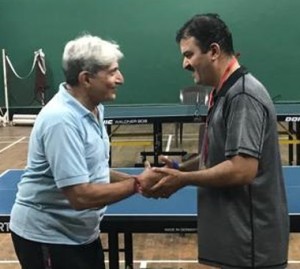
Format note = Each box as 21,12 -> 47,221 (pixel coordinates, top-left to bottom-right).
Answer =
0,166 -> 300,269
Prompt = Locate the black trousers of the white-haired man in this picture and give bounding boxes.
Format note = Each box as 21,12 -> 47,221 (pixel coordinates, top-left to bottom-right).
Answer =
11,230 -> 105,269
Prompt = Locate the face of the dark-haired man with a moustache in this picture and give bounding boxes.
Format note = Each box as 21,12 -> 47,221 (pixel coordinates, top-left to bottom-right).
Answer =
179,37 -> 212,85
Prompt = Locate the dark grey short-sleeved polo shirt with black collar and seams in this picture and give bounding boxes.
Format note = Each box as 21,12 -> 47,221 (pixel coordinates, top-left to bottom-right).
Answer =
198,68 -> 289,268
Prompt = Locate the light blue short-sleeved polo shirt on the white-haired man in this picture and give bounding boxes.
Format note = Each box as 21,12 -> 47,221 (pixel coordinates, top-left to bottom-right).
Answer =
10,84 -> 109,244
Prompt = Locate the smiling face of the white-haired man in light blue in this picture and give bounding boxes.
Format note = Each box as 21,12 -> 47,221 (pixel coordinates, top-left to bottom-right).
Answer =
89,62 -> 124,104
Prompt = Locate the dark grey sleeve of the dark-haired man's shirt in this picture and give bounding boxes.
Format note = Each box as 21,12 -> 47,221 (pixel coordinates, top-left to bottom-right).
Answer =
225,93 -> 267,159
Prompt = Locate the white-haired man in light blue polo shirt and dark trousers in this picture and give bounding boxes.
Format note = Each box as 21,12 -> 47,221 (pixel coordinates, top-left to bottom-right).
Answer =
10,34 -> 138,269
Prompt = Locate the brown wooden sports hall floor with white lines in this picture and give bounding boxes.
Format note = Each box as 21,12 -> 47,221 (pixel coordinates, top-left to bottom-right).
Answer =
0,124 -> 300,269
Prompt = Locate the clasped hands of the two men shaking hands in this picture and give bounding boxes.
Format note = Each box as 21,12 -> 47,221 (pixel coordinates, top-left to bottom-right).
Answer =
135,156 -> 184,199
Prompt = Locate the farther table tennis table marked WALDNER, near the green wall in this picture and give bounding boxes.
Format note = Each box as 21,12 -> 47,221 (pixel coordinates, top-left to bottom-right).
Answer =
10,101 -> 300,165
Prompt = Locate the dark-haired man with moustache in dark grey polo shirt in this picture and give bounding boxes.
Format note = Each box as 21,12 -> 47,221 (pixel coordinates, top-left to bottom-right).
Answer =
140,14 -> 289,269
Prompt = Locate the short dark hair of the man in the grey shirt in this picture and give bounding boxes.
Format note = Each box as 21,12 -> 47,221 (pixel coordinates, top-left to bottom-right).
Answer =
176,13 -> 234,55
